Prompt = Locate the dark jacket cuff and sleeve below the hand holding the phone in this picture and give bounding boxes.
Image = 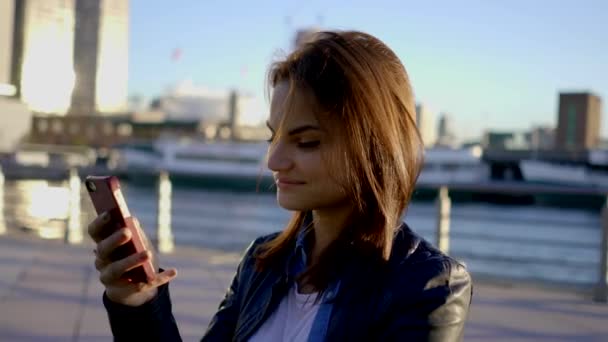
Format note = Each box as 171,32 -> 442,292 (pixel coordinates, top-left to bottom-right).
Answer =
103,284 -> 181,342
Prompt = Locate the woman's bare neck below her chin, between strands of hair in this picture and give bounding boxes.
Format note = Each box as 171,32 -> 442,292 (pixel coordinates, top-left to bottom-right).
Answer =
310,203 -> 352,263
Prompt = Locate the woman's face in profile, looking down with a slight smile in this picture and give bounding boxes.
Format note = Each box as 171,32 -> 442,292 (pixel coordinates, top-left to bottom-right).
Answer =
268,82 -> 348,211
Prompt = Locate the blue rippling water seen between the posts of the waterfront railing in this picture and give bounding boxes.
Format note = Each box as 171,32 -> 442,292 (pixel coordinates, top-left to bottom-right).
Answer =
4,181 -> 600,285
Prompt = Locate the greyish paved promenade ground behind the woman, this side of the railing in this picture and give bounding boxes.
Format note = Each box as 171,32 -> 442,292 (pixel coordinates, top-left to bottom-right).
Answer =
0,233 -> 608,342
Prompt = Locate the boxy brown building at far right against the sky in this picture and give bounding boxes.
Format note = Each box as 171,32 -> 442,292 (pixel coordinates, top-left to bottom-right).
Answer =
555,93 -> 602,150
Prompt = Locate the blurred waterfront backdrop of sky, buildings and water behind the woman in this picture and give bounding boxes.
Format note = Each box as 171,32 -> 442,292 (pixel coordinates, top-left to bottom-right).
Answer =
0,0 -> 608,340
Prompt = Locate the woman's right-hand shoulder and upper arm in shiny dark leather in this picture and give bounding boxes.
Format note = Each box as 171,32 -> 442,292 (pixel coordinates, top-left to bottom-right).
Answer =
370,224 -> 473,341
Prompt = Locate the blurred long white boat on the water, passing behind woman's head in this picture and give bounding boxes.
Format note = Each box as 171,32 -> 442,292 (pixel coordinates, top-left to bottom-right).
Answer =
116,140 -> 488,184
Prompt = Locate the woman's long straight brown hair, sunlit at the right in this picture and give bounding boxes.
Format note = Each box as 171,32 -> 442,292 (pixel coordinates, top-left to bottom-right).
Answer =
256,31 -> 424,291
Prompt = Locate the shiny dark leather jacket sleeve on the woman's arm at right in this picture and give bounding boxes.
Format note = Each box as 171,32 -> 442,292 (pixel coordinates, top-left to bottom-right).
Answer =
381,260 -> 473,342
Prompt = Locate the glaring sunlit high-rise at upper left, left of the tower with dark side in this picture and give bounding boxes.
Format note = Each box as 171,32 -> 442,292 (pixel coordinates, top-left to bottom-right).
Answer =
13,0 -> 75,113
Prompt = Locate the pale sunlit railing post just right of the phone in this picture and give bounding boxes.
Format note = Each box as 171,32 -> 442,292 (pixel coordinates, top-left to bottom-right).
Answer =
156,171 -> 175,253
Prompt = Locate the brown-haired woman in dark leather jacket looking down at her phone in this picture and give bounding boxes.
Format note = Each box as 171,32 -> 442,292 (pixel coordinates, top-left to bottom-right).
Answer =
89,32 -> 472,341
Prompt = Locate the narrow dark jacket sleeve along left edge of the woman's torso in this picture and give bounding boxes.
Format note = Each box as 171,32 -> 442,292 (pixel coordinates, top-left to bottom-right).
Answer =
201,239 -> 260,342
